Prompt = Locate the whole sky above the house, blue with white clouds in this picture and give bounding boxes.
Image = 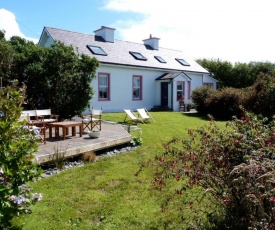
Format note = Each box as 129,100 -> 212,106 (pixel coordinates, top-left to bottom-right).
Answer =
0,0 -> 275,63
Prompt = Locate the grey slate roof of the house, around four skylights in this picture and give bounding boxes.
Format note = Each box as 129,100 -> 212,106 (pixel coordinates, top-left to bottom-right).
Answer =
39,27 -> 209,73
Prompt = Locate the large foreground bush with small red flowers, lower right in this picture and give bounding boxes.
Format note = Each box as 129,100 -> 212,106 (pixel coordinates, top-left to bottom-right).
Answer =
144,113 -> 275,229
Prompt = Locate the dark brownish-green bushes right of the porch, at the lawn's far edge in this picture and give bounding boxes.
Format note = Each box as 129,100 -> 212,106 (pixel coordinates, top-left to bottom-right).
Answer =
192,74 -> 275,120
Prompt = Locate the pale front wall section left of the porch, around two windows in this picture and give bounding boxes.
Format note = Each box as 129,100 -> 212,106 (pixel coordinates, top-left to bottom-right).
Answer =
87,65 -> 166,112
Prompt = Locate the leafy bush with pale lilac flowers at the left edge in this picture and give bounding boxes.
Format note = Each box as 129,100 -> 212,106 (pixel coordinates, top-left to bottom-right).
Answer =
0,82 -> 40,229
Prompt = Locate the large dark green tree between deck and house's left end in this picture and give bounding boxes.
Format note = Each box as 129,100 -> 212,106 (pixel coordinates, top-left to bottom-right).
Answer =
10,37 -> 99,119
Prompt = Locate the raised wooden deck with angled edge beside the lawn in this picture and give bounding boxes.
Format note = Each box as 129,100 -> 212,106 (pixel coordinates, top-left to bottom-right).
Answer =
35,123 -> 132,164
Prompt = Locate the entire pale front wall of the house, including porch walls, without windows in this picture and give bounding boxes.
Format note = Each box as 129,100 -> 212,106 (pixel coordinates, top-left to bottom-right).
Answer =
86,65 -> 219,112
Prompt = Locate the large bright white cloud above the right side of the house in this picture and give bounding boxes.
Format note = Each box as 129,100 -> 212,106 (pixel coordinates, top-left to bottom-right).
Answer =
105,0 -> 275,62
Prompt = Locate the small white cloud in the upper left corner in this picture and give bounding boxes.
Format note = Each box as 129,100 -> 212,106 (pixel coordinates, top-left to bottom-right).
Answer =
0,9 -> 38,43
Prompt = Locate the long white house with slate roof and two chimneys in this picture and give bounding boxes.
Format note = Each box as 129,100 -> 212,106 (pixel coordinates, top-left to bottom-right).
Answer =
38,26 -> 217,112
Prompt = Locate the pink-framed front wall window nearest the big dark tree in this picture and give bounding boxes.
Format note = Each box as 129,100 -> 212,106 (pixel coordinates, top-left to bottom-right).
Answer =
98,73 -> 110,101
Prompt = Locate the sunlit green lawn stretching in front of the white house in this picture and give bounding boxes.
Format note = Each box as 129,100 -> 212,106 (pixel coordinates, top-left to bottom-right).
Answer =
13,112 -> 226,230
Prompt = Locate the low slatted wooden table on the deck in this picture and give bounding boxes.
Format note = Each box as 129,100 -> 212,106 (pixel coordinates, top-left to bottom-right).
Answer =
47,121 -> 83,140
